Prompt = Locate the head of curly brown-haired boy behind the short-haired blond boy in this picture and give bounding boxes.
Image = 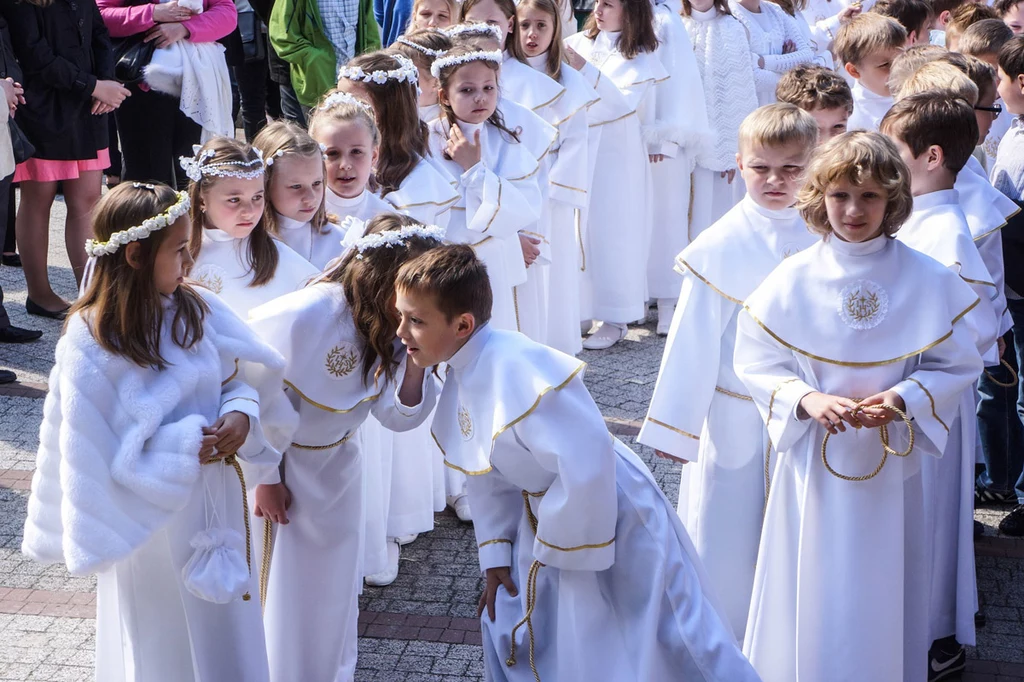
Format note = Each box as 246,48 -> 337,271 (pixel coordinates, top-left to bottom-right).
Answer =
775,65 -> 853,144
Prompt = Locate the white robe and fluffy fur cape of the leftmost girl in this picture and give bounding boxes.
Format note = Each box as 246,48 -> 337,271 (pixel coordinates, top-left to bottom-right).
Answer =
22,291 -> 295,682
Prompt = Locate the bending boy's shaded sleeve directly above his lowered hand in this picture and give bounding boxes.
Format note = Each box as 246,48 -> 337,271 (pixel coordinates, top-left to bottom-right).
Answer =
466,470 -> 523,570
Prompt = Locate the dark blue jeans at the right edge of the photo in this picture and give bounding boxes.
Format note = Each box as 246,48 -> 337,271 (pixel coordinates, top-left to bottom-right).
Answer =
977,299 -> 1024,504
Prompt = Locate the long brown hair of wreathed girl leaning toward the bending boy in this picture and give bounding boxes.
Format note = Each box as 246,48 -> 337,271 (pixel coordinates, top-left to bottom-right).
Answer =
317,213 -> 439,383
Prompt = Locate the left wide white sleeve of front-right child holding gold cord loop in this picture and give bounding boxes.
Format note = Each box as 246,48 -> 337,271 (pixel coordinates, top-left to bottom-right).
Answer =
733,310 -> 817,451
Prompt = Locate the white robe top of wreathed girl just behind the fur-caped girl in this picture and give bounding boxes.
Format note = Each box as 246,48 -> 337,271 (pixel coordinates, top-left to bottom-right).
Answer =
188,227 -> 319,319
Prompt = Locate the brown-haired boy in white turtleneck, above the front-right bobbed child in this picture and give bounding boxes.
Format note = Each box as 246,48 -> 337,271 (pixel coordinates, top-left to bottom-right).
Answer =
834,12 -> 906,130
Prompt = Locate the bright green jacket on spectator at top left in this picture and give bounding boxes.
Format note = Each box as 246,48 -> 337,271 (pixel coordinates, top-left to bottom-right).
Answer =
267,0 -> 381,106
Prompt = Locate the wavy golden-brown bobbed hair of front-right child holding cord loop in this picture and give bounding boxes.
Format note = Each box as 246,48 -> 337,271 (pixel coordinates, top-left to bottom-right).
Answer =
797,130 -> 913,237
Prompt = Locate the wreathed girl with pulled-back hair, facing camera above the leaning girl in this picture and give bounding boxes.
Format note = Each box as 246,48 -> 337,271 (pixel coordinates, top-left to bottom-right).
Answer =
308,90 -> 391,241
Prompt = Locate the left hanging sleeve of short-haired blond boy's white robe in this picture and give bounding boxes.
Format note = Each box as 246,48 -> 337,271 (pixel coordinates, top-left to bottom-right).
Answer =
637,272 -> 736,462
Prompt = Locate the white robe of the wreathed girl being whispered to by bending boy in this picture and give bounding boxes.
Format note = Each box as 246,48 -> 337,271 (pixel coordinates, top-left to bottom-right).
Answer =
250,282 -> 436,682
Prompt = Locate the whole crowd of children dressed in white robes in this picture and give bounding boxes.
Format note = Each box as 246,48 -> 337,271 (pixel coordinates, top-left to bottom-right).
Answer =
16,0 -> 1024,682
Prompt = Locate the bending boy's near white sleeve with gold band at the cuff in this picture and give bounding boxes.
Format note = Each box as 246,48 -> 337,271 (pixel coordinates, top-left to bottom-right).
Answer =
513,376 -> 618,570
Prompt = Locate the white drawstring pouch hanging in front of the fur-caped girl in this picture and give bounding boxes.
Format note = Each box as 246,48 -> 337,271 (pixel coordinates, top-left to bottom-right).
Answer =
181,463 -> 249,604
